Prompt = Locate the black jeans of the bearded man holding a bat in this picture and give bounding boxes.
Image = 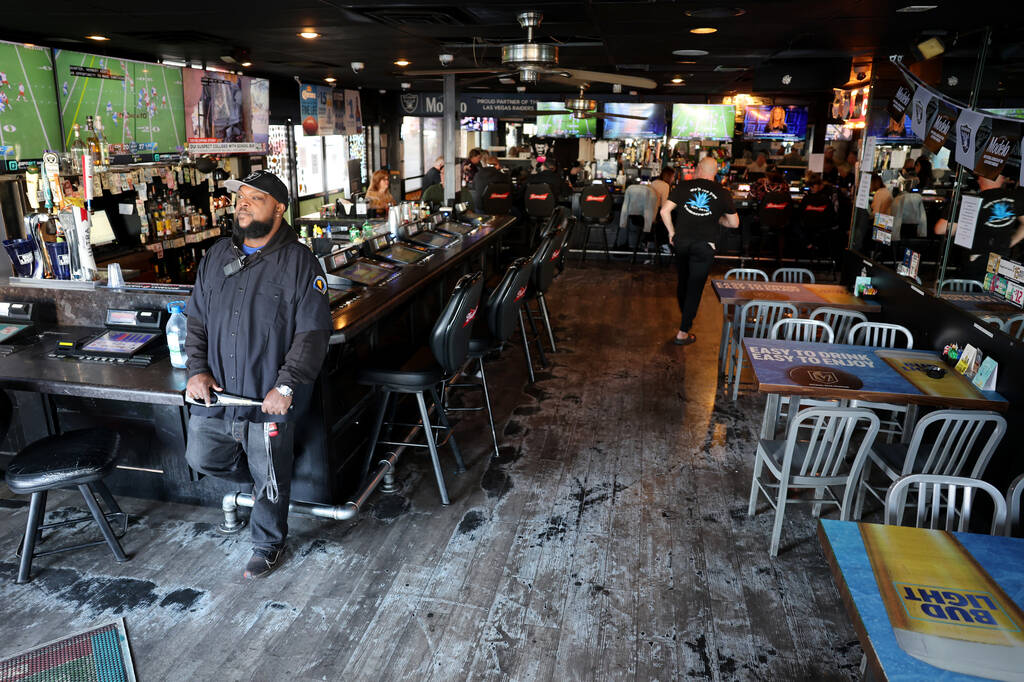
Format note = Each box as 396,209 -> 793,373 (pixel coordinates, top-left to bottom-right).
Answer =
185,415 -> 295,552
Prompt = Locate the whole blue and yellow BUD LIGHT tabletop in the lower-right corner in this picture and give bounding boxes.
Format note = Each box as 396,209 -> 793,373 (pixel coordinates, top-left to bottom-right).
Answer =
818,519 -> 1024,682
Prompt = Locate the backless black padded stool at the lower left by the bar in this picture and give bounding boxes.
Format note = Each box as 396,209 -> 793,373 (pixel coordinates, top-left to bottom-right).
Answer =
7,421 -> 128,583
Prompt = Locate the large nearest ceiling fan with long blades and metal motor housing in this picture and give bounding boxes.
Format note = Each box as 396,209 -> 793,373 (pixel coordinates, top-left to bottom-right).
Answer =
402,11 -> 657,90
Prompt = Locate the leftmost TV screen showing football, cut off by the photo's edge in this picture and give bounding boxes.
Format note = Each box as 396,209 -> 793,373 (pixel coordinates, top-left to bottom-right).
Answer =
0,41 -> 60,160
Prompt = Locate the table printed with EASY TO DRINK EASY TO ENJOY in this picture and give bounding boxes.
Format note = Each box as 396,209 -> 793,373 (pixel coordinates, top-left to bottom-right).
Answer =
742,337 -> 1009,438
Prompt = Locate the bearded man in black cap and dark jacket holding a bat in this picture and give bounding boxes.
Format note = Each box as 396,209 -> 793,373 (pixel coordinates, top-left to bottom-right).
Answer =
185,171 -> 331,578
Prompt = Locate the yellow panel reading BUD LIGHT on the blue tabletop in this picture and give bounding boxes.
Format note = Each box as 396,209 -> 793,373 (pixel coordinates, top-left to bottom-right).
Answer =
860,523 -> 1024,680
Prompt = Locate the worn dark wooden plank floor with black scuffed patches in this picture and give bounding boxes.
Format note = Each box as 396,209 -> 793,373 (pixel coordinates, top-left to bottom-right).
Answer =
0,263 -> 861,681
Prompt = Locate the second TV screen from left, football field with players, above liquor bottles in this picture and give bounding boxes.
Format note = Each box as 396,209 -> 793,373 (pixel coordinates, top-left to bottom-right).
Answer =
56,50 -> 185,153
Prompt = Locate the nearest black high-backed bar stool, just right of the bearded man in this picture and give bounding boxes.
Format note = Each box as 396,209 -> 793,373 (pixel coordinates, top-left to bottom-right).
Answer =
355,272 -> 483,505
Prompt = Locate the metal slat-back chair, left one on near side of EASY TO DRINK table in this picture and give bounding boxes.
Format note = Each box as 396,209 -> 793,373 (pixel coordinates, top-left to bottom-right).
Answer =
746,408 -> 879,556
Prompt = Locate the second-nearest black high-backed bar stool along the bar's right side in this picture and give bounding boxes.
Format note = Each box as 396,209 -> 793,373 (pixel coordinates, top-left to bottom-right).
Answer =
449,258 -> 534,457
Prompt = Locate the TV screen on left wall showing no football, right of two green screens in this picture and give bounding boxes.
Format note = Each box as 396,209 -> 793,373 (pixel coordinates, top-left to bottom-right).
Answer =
182,69 -> 270,154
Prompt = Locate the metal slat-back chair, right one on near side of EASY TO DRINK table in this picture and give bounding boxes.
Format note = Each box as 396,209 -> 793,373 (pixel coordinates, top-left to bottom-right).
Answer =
855,410 -> 1007,518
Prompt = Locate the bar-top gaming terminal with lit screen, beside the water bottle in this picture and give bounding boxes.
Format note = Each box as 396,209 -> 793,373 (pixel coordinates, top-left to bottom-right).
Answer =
49,308 -> 167,367
